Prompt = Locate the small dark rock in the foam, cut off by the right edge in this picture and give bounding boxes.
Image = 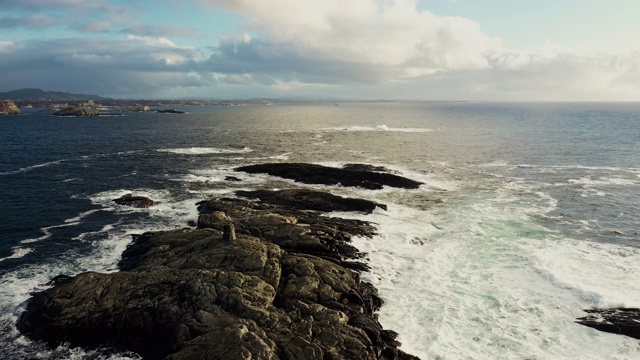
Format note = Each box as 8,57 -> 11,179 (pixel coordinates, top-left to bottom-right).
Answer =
576,308 -> 640,339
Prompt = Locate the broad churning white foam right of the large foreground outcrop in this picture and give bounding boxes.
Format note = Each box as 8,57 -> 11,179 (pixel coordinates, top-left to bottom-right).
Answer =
324,174 -> 640,359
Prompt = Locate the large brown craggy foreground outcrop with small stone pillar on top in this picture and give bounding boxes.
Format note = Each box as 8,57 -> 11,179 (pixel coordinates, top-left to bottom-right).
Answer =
18,190 -> 415,360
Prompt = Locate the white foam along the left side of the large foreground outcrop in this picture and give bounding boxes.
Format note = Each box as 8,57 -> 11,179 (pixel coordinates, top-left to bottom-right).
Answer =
0,189 -> 208,360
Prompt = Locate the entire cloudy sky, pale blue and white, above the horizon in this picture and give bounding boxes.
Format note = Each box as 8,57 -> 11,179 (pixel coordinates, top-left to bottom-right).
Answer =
0,0 -> 640,101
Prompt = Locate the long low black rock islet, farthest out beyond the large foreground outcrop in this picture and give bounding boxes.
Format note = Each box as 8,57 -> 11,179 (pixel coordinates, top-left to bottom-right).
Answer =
236,163 -> 422,190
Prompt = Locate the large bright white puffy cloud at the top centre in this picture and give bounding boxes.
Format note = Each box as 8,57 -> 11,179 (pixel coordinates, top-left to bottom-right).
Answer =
201,0 -> 500,77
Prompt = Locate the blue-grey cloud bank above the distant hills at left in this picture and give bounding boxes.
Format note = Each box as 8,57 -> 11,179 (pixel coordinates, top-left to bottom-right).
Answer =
0,36 -> 211,96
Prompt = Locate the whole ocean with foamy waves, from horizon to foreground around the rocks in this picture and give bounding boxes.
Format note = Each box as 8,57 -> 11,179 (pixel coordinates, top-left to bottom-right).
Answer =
0,102 -> 640,360
